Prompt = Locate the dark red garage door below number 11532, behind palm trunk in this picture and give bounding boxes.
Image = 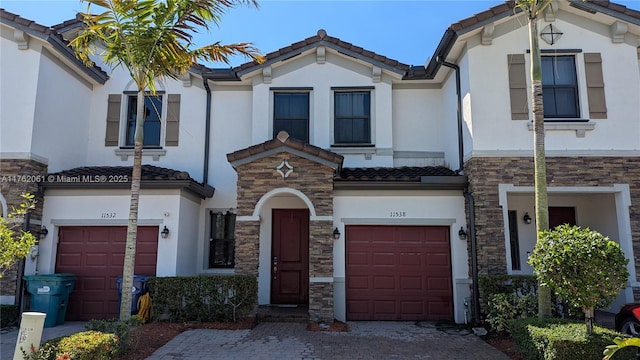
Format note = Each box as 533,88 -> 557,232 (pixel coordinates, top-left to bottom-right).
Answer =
56,226 -> 158,320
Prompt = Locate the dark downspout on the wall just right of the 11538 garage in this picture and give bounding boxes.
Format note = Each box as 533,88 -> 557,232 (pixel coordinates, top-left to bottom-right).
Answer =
436,57 -> 480,323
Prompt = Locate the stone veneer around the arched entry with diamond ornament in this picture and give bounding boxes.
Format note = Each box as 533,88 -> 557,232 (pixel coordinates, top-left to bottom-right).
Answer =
235,152 -> 334,320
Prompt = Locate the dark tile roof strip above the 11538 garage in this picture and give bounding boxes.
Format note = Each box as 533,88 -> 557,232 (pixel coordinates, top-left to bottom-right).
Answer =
335,166 -> 459,182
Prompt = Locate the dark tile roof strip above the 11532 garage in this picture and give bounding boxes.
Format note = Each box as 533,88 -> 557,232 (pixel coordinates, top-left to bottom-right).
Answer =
41,165 -> 214,198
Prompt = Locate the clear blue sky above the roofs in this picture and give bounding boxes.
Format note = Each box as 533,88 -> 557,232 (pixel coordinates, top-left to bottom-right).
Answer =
0,0 -> 640,67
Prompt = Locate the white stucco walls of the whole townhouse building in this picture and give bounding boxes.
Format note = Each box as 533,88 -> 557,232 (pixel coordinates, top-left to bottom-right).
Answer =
0,0 -> 640,323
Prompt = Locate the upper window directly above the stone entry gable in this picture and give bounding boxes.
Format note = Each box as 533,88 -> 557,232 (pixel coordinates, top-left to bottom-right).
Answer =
273,92 -> 309,143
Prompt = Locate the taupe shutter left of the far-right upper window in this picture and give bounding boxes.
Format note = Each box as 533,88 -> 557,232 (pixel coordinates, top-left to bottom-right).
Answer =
507,54 -> 529,120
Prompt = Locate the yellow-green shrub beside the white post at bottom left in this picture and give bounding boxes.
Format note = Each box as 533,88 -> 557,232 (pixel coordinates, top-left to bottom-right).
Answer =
23,330 -> 120,360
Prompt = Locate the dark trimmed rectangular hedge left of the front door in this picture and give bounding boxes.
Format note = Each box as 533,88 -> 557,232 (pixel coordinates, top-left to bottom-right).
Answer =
147,275 -> 258,322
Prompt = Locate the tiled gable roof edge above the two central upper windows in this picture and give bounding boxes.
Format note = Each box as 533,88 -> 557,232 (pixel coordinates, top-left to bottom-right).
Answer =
233,29 -> 411,77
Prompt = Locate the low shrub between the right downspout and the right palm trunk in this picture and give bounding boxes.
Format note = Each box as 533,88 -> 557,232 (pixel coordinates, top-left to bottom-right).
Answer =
486,293 -> 538,333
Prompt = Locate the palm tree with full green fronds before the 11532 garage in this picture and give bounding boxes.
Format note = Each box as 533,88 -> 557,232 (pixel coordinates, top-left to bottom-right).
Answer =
71,0 -> 262,320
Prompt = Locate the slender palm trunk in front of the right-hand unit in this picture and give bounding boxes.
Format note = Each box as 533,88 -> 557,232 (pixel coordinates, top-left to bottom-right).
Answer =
515,0 -> 552,317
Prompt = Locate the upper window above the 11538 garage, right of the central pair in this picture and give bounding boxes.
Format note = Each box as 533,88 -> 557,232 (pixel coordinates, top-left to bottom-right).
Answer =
334,91 -> 371,145
